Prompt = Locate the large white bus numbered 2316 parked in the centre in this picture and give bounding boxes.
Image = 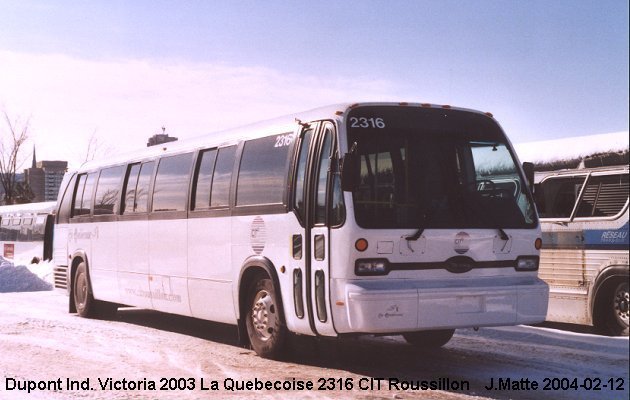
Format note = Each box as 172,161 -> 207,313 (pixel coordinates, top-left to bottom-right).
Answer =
54,103 -> 548,358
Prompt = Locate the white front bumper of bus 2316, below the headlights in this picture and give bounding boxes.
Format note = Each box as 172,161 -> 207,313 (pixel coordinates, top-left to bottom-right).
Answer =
335,277 -> 549,333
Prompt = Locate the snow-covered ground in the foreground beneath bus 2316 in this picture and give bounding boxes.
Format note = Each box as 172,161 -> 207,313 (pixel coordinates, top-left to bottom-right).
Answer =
0,291 -> 630,400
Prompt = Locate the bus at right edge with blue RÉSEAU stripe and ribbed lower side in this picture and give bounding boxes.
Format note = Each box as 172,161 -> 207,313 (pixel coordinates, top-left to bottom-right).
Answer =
536,164 -> 630,336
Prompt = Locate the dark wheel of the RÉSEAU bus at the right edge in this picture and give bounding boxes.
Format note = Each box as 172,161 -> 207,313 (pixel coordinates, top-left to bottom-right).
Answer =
593,278 -> 630,336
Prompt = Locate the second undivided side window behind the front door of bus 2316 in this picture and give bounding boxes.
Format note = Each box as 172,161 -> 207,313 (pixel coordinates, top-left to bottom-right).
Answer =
153,153 -> 193,211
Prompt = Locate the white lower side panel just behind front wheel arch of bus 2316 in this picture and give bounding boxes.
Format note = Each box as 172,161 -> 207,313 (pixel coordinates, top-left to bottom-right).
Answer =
188,217 -> 238,324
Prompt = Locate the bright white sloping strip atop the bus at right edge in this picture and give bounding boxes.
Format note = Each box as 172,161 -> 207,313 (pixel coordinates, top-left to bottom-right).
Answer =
514,131 -> 628,163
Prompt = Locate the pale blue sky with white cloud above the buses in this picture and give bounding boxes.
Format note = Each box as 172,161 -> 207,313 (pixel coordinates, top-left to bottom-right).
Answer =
0,0 -> 629,166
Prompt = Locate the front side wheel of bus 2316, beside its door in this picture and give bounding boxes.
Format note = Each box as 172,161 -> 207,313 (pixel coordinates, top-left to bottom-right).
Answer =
245,278 -> 287,359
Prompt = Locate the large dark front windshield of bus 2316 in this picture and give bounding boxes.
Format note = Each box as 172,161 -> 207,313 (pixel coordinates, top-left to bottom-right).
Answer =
347,106 -> 537,229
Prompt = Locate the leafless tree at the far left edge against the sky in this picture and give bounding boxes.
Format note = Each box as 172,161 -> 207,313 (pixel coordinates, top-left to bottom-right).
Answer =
0,111 -> 29,204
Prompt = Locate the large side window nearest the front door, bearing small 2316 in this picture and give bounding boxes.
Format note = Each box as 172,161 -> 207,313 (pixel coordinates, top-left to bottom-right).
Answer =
236,132 -> 294,206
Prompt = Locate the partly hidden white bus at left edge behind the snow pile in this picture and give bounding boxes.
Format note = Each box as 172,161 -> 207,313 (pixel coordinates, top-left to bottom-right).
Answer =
0,201 -> 57,264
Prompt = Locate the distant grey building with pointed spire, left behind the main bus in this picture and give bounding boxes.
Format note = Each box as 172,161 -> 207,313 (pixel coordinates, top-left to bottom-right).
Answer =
24,150 -> 68,203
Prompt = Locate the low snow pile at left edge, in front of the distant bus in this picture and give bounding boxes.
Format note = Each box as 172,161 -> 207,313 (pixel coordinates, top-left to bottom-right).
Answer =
0,259 -> 53,293
